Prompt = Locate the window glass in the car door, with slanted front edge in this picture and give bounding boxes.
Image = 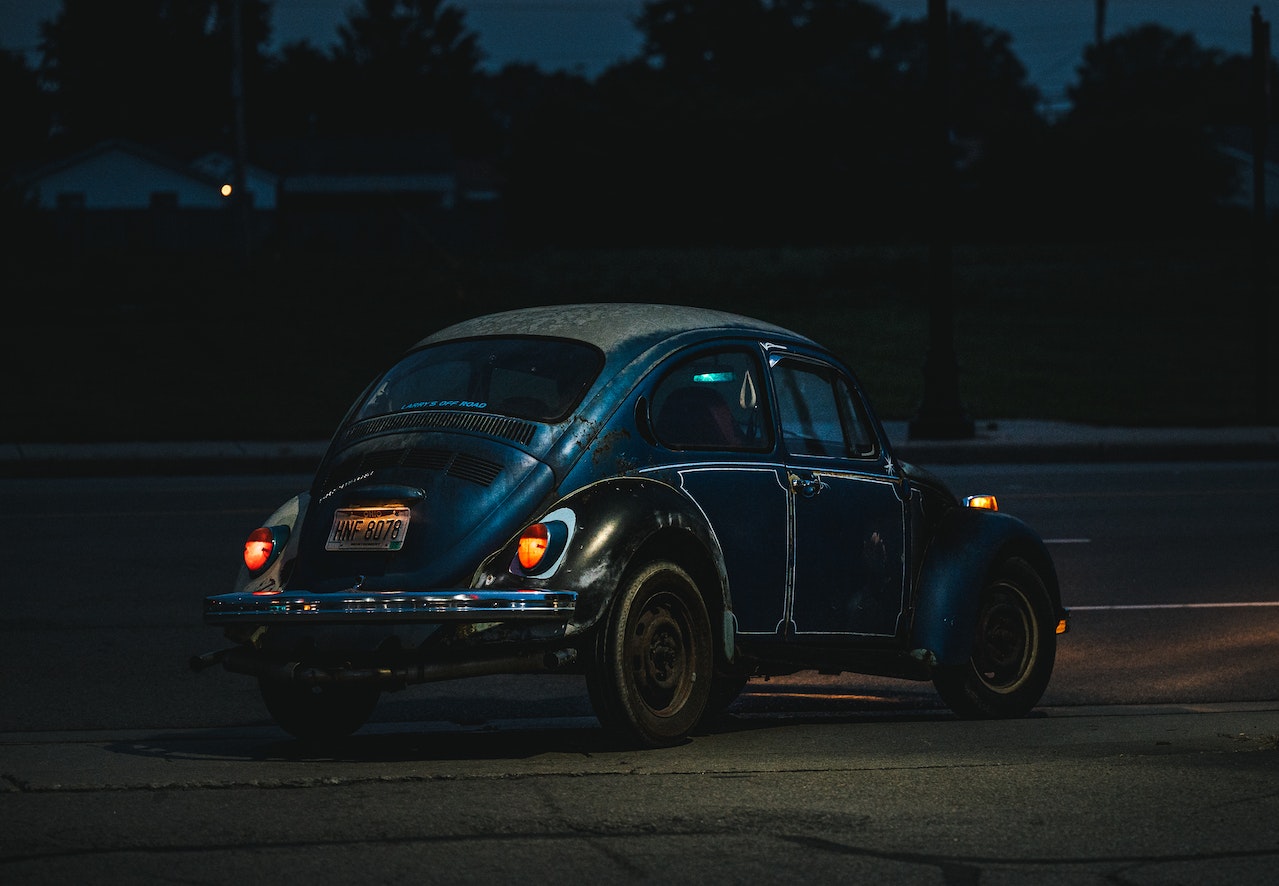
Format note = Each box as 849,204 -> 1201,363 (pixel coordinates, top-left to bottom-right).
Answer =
773,359 -> 875,458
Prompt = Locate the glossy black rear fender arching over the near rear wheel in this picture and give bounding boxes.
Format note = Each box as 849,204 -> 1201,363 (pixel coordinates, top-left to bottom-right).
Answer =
472,477 -> 732,632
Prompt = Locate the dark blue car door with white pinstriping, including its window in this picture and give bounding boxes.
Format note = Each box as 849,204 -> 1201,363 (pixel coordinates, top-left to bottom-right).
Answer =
770,353 -> 908,639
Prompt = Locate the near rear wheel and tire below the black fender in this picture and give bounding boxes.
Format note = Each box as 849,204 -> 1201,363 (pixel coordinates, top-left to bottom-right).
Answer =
586,561 -> 715,748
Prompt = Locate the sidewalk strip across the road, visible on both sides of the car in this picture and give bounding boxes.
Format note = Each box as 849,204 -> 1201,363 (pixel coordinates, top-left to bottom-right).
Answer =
0,419 -> 1279,477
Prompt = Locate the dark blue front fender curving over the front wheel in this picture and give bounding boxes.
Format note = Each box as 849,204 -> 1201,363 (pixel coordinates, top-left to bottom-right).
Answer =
909,508 -> 1062,665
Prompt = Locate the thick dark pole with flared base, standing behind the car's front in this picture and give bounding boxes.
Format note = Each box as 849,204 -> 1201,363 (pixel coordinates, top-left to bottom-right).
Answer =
909,0 -> 973,440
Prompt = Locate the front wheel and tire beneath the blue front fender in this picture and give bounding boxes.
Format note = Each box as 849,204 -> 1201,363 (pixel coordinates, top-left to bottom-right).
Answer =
932,557 -> 1056,720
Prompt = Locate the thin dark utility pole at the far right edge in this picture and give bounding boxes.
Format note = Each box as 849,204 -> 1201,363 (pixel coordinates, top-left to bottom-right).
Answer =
1252,6 -> 1270,424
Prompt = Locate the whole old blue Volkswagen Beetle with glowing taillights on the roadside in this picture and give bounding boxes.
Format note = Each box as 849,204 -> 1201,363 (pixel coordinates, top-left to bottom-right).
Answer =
197,304 -> 1067,747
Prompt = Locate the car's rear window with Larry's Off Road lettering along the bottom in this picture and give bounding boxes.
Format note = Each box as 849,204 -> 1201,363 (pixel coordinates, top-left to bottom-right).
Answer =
356,336 -> 604,422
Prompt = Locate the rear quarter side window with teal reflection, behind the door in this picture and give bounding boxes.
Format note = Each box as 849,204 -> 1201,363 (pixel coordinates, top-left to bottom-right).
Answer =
651,349 -> 773,451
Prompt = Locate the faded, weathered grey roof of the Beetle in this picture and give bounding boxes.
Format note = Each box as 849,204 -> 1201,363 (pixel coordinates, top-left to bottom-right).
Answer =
417,303 -> 816,354
